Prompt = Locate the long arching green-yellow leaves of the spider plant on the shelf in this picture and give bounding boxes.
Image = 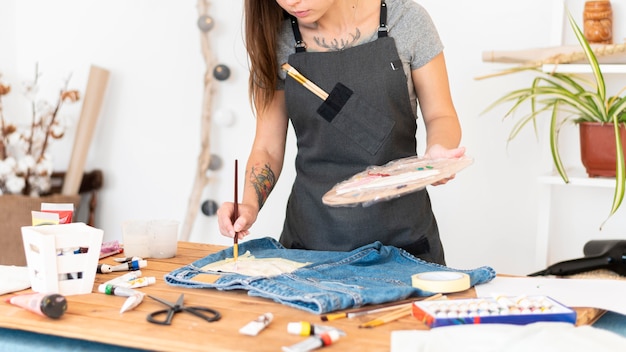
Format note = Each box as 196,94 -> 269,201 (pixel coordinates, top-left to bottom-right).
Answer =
485,12 -> 626,224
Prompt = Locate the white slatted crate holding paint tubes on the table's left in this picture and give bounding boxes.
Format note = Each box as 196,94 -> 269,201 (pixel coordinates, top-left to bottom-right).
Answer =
22,223 -> 104,295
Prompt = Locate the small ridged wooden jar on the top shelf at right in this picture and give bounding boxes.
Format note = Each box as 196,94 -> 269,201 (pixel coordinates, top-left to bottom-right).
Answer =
583,0 -> 613,44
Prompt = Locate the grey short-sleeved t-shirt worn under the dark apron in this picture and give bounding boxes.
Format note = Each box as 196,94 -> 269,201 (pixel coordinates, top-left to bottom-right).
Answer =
276,0 -> 443,111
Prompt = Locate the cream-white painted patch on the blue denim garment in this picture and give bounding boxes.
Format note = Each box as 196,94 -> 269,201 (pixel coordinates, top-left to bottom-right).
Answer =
201,251 -> 311,277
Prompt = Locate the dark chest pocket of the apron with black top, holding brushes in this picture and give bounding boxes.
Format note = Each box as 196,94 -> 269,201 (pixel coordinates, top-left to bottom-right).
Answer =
317,83 -> 395,155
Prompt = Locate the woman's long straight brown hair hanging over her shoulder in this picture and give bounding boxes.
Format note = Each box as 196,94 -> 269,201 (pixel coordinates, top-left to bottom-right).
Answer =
244,0 -> 284,111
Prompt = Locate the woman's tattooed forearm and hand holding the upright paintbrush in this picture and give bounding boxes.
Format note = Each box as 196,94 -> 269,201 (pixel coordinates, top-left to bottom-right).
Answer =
217,90 -> 289,237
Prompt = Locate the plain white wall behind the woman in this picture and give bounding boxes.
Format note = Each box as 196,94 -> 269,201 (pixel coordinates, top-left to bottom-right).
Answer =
0,0 -> 626,274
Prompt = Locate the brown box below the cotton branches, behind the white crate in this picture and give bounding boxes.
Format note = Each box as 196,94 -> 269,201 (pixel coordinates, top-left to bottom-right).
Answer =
0,194 -> 81,266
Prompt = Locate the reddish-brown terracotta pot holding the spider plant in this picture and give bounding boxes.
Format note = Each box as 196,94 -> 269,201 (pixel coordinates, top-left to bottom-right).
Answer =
578,122 -> 626,177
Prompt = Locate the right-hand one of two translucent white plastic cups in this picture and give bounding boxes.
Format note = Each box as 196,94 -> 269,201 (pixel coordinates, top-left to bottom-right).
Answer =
147,220 -> 179,258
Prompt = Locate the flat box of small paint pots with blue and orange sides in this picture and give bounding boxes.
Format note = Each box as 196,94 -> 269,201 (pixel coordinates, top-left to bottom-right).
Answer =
412,296 -> 576,328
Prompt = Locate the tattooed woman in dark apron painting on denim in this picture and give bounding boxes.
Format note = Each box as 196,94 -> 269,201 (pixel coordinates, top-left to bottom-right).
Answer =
218,0 -> 465,264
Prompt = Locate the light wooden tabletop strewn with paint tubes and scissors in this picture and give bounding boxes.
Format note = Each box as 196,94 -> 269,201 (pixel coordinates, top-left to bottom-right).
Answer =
0,242 -> 601,352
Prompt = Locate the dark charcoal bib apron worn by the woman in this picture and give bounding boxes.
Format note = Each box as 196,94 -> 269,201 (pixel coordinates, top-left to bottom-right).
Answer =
280,0 -> 445,264
